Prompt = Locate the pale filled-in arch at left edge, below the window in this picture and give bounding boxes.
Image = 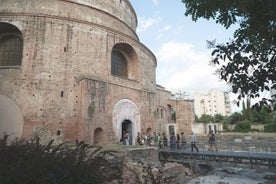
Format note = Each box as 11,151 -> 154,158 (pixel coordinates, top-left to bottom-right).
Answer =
0,95 -> 24,139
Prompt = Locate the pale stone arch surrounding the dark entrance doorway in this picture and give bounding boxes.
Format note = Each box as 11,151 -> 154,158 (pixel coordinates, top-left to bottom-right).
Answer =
112,99 -> 141,144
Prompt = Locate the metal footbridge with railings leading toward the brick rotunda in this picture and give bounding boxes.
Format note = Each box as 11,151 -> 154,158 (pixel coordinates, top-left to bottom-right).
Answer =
159,140 -> 276,168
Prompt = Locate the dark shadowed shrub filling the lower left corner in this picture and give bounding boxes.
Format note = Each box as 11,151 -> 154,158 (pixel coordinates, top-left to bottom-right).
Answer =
0,136 -> 121,184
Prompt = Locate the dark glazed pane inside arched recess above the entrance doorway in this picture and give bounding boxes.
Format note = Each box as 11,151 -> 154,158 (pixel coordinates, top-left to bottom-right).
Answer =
111,51 -> 128,78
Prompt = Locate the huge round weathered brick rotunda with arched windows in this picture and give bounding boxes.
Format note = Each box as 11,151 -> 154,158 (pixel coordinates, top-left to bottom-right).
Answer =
0,0 -> 194,144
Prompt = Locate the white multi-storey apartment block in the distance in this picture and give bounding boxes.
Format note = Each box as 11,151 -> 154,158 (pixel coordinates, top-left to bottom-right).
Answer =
194,89 -> 231,117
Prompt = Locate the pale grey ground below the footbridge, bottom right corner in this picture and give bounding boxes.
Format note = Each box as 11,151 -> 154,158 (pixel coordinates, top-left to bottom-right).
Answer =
186,167 -> 276,184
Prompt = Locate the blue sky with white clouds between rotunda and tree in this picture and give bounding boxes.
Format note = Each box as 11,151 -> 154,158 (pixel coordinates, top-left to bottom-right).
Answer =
130,0 -> 242,110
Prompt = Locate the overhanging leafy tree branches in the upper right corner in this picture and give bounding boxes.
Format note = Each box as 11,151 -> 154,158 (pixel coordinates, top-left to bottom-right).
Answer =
182,0 -> 276,108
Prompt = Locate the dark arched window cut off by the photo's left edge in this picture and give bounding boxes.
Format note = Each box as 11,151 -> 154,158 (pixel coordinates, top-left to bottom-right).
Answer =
0,23 -> 23,67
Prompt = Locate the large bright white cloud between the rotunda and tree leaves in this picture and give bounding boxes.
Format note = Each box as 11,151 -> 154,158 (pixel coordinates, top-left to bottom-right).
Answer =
157,41 -> 226,92
